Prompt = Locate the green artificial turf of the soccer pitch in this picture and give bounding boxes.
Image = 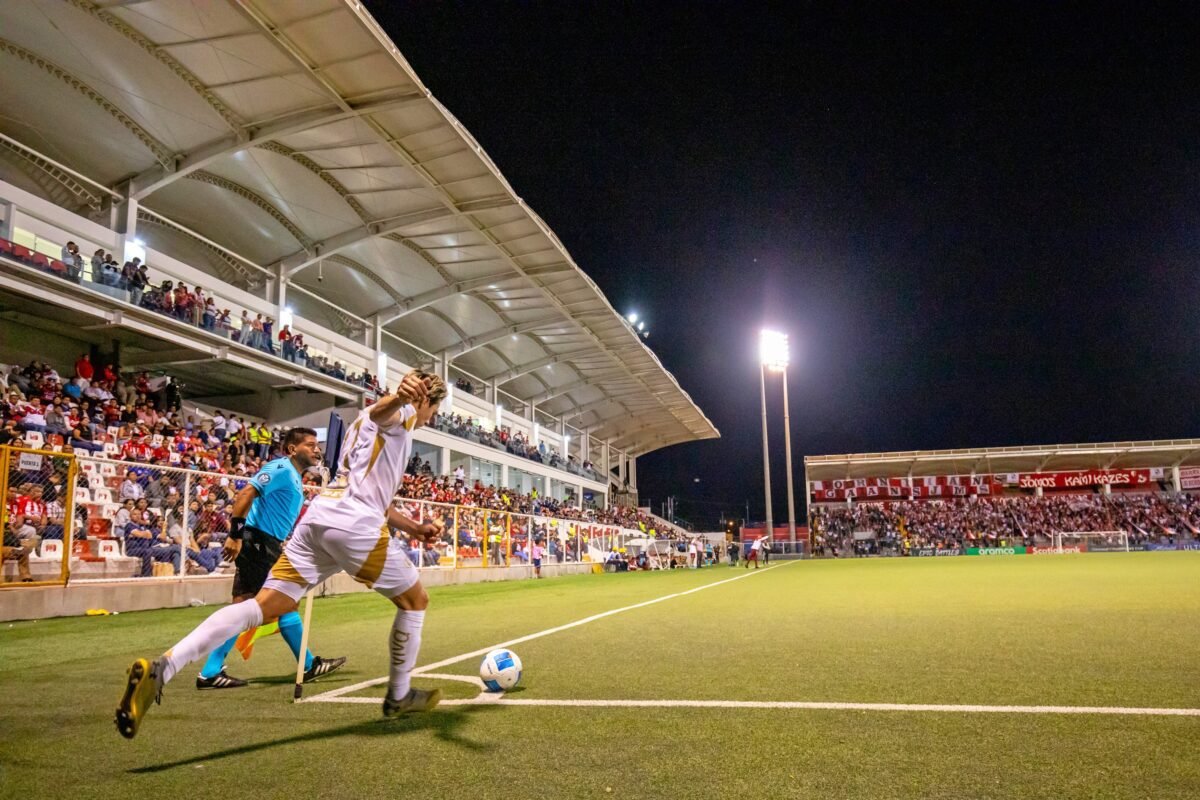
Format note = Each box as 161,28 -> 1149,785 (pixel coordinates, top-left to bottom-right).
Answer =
0,553 -> 1200,800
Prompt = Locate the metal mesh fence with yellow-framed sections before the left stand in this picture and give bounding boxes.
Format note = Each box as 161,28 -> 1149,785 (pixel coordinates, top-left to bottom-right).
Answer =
0,443 -> 646,585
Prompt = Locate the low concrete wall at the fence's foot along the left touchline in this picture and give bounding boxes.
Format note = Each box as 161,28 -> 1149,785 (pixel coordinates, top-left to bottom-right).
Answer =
0,561 -> 594,622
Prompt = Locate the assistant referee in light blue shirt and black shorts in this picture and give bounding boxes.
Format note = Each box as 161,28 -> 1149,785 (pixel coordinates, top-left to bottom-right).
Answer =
196,428 -> 346,688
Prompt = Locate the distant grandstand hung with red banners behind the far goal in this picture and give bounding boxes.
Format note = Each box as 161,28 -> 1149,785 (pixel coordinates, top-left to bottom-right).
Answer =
801,439 -> 1200,555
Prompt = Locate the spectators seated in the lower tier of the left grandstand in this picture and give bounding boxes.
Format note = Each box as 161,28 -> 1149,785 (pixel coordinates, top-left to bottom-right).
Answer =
0,354 -> 672,577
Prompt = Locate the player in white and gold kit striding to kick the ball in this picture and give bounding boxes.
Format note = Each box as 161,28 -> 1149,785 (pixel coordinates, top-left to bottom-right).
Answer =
116,372 -> 446,739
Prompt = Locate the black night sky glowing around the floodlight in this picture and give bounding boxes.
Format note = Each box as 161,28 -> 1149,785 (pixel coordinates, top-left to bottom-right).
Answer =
367,0 -> 1200,532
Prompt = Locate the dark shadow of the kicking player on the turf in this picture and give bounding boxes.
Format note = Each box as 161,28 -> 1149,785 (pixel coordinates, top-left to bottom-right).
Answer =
130,703 -> 497,775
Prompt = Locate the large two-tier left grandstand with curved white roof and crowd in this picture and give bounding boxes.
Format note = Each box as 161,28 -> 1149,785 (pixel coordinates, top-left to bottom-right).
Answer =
0,0 -> 719,618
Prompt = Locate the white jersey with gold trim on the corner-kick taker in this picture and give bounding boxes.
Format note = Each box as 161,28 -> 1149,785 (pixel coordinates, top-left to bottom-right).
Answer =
304,405 -> 416,533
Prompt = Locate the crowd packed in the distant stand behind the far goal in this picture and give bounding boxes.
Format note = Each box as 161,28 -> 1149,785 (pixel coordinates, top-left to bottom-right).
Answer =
810,493 -> 1200,552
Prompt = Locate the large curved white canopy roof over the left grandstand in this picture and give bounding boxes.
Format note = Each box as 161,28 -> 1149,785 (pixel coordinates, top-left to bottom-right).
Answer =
0,0 -> 719,455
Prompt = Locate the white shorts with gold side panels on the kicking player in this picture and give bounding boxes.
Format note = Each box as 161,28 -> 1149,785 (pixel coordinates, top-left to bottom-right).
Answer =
263,523 -> 418,601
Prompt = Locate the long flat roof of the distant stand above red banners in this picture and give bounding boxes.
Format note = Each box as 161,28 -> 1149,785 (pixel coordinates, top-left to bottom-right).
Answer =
804,439 -> 1200,481
